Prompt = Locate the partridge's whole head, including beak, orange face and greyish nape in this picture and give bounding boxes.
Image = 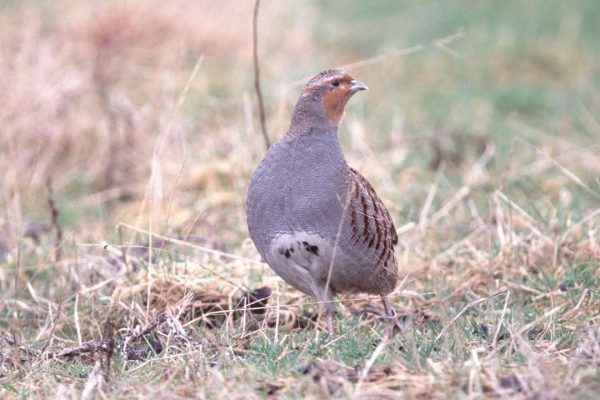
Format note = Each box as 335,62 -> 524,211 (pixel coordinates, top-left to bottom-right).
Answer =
294,69 -> 369,130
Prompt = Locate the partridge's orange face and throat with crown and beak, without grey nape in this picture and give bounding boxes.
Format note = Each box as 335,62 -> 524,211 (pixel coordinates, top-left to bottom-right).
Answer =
305,70 -> 368,126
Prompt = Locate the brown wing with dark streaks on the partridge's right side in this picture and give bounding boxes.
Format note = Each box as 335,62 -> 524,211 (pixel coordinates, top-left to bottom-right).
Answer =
349,168 -> 398,266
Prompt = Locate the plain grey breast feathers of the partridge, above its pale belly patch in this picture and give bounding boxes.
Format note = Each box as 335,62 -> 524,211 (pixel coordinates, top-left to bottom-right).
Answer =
246,129 -> 349,258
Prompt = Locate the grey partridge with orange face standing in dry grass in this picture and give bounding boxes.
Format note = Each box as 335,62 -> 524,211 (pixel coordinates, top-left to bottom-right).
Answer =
246,69 -> 402,337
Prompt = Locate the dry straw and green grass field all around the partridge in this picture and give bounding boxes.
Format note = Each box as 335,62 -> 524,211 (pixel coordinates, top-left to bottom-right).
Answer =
0,0 -> 600,399
